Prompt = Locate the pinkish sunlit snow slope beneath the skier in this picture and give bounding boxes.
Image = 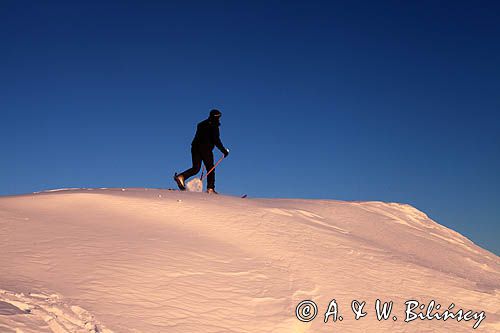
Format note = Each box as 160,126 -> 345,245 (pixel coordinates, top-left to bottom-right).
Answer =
0,189 -> 500,333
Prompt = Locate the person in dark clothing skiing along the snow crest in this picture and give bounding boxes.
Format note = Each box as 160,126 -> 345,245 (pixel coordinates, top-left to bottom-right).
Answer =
174,109 -> 229,193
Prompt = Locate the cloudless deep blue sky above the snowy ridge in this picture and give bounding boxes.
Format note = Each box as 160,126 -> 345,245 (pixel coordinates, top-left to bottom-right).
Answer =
0,0 -> 500,253
